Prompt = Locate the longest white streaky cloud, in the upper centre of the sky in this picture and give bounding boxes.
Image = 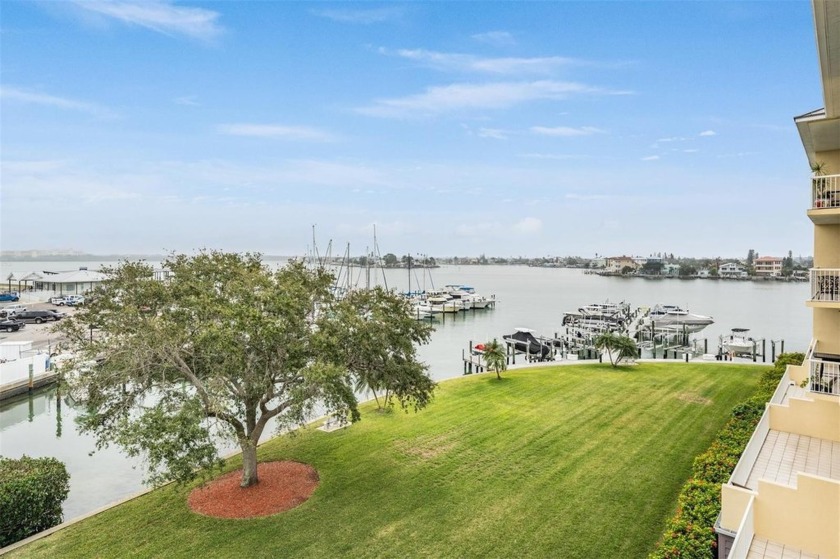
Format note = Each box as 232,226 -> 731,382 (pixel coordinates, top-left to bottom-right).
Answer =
356,80 -> 624,118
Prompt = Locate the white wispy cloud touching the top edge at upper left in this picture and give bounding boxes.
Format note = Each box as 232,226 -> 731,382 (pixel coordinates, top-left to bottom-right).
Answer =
75,0 -> 223,41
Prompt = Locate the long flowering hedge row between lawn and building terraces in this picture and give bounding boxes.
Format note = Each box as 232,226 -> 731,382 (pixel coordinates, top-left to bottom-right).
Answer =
648,353 -> 805,559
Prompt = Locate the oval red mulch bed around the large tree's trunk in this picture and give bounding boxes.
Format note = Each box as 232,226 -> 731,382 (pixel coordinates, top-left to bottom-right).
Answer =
188,461 -> 319,518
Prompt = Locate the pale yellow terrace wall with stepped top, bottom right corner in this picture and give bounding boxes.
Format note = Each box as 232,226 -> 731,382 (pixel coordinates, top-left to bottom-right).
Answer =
753,474 -> 840,559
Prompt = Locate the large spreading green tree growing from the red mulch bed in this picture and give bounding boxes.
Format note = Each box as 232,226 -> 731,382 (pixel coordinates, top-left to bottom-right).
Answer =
59,251 -> 434,486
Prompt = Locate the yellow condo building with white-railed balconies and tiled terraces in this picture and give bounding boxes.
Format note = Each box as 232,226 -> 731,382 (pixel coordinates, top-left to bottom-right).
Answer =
716,0 -> 840,559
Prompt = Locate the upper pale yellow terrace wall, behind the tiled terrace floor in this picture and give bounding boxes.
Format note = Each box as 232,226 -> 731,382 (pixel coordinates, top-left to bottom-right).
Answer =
769,397 -> 840,442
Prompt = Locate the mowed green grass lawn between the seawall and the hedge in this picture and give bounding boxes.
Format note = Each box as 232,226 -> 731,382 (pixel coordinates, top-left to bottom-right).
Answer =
10,363 -> 765,559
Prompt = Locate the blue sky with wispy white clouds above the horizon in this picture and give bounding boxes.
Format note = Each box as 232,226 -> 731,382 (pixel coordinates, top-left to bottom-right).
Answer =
0,0 -> 823,257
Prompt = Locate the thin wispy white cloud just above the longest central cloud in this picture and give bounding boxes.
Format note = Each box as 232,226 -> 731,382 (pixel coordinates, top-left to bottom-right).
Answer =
379,49 -> 581,75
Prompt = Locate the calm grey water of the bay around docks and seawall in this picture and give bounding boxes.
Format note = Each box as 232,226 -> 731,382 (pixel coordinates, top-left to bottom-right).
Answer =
0,262 -> 811,519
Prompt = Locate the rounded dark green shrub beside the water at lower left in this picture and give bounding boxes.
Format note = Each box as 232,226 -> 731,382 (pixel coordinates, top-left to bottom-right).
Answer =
0,456 -> 70,547
